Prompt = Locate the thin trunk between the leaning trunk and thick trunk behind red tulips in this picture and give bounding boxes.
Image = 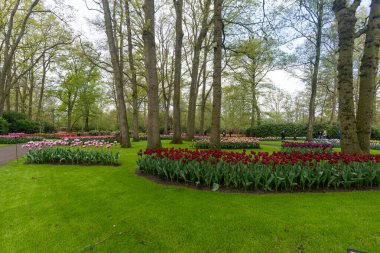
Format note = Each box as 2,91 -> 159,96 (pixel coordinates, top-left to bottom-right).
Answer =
125,0 -> 139,142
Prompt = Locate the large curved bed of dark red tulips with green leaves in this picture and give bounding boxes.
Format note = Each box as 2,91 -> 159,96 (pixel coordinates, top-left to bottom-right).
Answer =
137,148 -> 380,191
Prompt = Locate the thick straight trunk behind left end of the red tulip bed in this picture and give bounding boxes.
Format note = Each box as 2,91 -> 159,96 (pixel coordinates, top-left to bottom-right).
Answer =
143,0 -> 161,149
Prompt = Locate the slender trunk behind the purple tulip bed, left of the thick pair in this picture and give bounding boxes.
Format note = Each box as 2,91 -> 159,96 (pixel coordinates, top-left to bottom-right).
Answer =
306,0 -> 324,141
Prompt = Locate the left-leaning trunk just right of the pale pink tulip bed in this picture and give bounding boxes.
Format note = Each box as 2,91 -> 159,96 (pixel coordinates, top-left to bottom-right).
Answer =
102,0 -> 131,148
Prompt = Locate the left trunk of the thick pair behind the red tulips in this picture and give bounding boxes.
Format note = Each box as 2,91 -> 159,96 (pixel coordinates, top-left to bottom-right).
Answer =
333,0 -> 361,153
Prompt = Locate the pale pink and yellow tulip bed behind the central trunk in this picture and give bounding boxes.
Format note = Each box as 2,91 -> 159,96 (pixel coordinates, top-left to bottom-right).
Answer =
194,137 -> 260,149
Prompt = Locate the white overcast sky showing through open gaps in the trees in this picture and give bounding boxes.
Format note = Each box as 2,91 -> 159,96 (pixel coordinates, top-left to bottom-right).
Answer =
46,0 -> 371,93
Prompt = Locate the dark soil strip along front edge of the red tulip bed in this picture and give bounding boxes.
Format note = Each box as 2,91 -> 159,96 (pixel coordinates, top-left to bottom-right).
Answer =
135,169 -> 380,194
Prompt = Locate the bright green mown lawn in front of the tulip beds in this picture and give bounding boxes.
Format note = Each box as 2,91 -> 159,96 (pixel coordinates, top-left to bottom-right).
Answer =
0,141 -> 380,253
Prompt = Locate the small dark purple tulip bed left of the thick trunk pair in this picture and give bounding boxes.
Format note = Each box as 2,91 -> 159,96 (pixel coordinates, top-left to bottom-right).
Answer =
281,142 -> 333,153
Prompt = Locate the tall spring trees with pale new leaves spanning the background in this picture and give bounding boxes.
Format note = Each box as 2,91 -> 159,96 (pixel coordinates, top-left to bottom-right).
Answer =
0,0 -> 379,153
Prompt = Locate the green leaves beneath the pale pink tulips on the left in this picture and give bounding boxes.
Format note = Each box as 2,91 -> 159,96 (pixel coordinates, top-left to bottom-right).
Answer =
26,147 -> 119,165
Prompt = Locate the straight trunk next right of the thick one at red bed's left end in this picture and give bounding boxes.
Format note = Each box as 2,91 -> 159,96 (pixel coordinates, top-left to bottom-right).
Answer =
172,0 -> 183,144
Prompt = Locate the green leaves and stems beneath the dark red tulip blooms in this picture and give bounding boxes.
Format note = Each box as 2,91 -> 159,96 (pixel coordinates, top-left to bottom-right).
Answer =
137,156 -> 380,191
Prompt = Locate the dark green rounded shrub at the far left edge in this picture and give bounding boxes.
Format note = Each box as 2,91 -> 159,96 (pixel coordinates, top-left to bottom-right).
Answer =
3,112 -> 40,134
